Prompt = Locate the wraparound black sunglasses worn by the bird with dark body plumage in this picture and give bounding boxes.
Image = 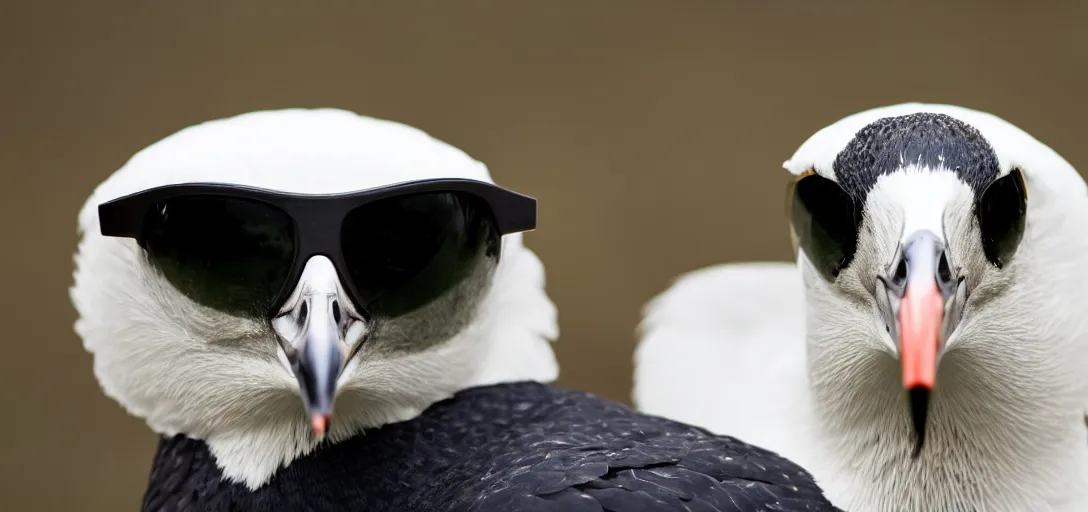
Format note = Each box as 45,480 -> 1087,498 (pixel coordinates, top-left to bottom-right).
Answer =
98,178 -> 536,317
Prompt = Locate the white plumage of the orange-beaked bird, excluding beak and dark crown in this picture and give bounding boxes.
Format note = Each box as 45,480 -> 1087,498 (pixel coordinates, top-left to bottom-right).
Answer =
634,103 -> 1088,512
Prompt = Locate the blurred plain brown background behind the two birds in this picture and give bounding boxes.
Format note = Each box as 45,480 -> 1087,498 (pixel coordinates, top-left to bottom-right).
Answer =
0,0 -> 1088,511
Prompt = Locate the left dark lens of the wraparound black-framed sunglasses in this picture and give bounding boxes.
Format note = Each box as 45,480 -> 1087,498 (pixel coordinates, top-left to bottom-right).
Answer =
141,197 -> 295,314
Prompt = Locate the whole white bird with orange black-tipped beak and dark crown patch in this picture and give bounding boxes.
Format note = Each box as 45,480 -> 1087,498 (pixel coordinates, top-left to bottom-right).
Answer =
635,103 -> 1088,512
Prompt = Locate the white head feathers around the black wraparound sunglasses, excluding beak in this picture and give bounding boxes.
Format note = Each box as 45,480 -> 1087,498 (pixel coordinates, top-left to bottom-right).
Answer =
71,109 -> 558,488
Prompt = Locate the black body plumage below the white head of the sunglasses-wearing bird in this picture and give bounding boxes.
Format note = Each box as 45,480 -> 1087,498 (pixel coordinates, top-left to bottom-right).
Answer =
143,383 -> 837,512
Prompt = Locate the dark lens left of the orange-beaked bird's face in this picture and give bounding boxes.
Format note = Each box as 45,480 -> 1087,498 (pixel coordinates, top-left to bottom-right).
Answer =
789,173 -> 862,280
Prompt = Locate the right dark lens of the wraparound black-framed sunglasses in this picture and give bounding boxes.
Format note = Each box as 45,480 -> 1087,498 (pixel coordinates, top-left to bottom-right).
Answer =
342,192 -> 499,316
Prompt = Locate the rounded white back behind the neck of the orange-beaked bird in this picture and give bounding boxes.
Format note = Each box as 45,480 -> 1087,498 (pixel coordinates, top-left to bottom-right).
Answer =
634,262 -> 809,467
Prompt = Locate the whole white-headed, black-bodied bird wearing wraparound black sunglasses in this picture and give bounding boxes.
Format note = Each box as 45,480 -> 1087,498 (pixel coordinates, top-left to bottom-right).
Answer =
72,110 -> 832,512
